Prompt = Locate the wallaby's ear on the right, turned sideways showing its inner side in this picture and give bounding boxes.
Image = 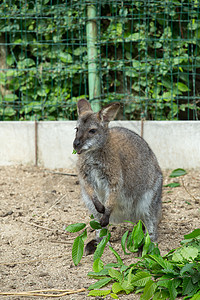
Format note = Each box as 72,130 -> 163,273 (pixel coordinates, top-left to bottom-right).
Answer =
98,102 -> 120,123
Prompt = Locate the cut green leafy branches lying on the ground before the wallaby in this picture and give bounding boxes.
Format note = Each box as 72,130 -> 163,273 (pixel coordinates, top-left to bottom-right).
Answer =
67,220 -> 200,300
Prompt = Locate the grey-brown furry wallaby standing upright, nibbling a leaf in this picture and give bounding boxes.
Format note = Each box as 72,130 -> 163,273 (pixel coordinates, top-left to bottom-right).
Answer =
73,99 -> 162,252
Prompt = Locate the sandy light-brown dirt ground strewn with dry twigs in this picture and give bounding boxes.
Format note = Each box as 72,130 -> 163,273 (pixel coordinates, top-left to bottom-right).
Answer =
0,166 -> 200,300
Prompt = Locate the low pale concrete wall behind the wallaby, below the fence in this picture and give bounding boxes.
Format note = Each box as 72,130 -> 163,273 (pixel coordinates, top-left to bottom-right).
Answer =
0,121 -> 200,169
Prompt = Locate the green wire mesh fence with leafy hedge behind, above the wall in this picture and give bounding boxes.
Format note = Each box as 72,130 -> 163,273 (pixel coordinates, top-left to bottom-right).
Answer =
0,0 -> 200,120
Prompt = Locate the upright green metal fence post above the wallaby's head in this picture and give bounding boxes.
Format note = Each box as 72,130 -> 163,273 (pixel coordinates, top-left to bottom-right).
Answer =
86,4 -> 101,112
